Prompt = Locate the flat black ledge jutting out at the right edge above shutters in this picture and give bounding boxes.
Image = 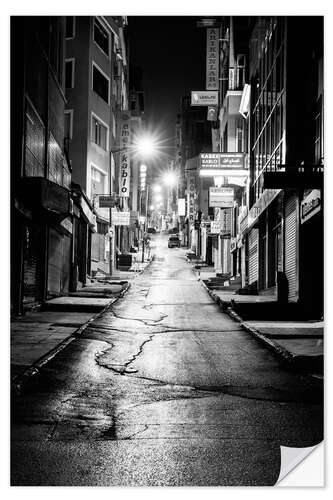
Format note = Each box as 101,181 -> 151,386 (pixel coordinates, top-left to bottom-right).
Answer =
262,164 -> 324,189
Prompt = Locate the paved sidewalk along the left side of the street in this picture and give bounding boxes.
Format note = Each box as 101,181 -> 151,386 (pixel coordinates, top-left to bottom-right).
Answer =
10,261 -> 150,390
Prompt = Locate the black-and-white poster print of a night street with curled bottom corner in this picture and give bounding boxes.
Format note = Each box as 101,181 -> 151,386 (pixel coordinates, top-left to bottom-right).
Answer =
10,12 -> 326,488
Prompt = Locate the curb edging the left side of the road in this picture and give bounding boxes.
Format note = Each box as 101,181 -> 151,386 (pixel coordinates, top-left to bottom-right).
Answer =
11,282 -> 131,395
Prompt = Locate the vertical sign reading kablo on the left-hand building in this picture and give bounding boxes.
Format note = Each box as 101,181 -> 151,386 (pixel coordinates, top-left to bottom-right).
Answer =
119,111 -> 131,197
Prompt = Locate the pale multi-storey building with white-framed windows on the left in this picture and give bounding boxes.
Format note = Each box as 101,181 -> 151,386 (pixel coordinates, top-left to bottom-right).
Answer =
65,16 -> 128,283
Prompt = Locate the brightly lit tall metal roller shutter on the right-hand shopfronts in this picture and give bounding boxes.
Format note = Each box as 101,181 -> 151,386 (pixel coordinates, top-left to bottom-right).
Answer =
284,196 -> 298,302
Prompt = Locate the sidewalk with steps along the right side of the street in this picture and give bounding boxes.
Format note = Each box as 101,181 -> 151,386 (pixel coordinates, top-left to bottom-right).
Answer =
194,268 -> 324,373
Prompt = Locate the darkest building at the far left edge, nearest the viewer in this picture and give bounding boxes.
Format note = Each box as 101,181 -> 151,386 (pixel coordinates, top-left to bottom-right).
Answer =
11,16 -> 73,313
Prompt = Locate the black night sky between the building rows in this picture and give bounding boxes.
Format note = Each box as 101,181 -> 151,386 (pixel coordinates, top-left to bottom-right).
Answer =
127,16 -> 206,163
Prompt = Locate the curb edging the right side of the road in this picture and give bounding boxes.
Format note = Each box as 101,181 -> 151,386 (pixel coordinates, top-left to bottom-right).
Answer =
198,276 -> 323,371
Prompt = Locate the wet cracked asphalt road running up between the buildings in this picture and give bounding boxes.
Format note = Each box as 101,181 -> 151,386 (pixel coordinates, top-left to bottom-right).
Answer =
11,235 -> 323,486
